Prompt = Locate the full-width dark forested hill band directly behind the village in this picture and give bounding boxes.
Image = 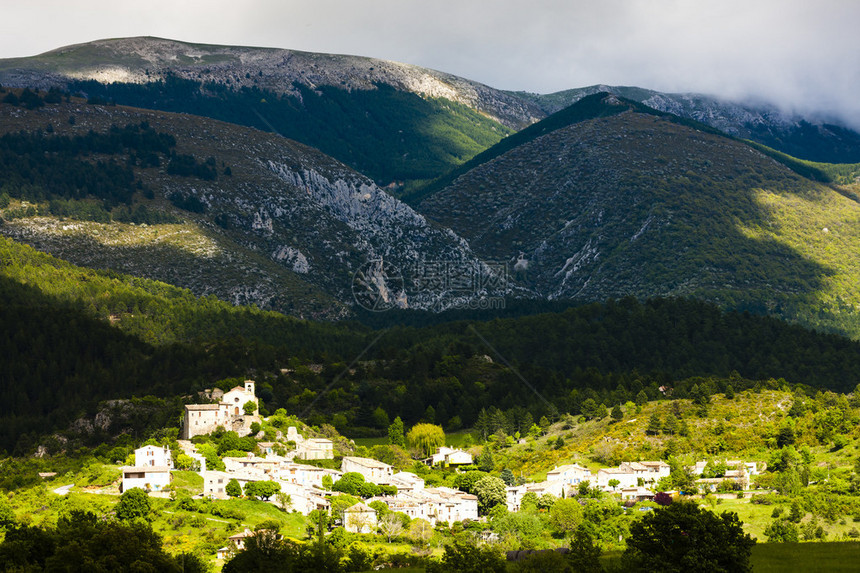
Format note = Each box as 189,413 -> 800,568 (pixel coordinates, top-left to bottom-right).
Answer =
6,227 -> 860,449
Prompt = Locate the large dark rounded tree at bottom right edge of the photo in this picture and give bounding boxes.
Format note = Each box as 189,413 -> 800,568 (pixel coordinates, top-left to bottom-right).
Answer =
624,502 -> 755,573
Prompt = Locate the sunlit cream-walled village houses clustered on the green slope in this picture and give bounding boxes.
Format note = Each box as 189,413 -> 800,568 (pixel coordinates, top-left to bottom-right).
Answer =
116,380 -> 763,558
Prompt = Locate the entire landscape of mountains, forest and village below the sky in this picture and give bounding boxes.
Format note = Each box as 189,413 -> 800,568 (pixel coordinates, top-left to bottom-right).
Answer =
0,37 -> 860,573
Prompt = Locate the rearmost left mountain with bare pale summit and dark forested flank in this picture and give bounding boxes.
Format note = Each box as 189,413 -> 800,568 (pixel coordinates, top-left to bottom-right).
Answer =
0,37 -> 532,187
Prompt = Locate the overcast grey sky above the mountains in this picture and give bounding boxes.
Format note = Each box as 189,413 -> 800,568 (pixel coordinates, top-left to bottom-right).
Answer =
5,0 -> 860,126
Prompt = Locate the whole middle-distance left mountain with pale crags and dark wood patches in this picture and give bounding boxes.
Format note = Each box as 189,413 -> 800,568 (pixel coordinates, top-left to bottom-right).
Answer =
0,90 -> 488,318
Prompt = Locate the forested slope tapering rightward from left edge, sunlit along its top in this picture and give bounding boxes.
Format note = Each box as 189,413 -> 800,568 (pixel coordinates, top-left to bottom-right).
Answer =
0,238 -> 364,452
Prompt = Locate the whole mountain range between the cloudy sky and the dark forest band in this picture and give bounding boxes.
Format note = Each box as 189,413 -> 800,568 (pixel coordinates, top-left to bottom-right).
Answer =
0,38 -> 860,336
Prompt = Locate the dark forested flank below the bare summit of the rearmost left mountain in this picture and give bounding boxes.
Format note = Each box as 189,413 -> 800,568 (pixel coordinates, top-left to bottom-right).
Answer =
69,76 -> 513,185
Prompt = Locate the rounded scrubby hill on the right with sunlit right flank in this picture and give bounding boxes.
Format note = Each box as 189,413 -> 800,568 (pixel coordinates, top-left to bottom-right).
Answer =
416,94 -> 860,337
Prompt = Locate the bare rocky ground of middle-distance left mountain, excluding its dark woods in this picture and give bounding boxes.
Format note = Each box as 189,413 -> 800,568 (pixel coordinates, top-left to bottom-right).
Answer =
0,97 -> 507,316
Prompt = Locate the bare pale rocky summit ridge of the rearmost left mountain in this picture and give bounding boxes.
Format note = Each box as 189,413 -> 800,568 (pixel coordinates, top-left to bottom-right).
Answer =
0,36 -> 537,127
